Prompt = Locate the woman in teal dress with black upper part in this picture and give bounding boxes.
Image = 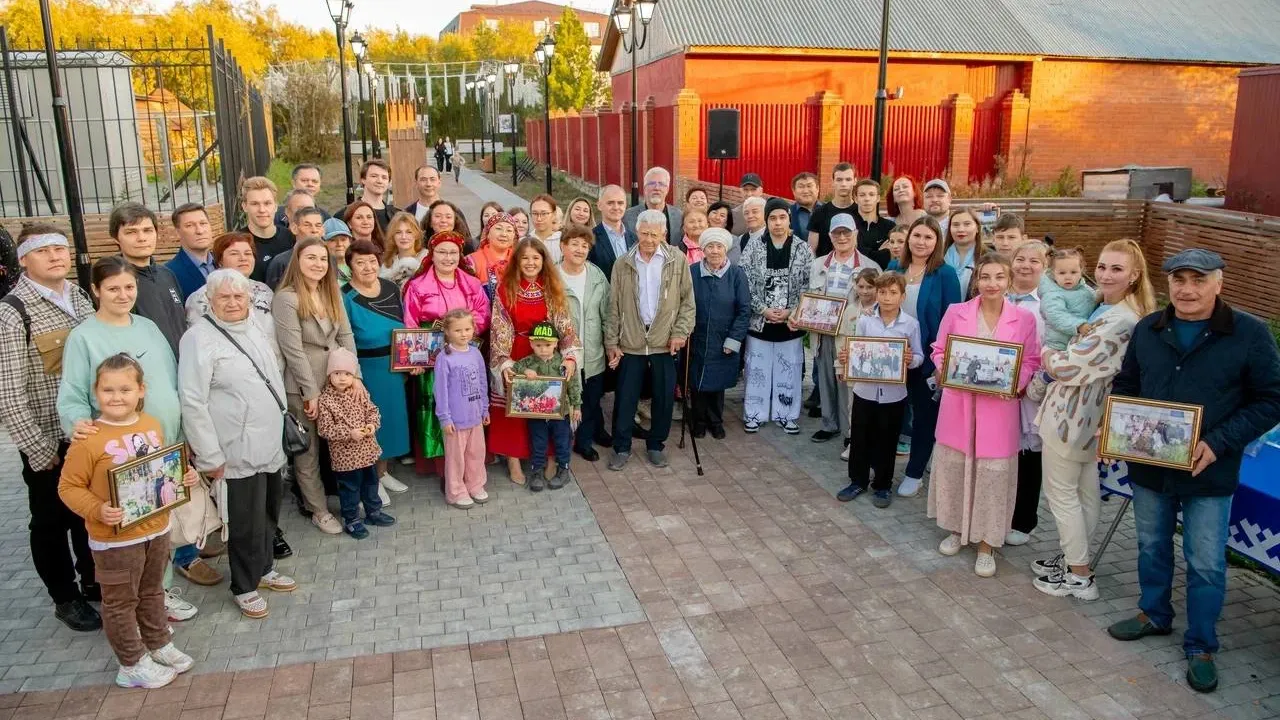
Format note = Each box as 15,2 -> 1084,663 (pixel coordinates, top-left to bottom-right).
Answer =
342,241 -> 410,492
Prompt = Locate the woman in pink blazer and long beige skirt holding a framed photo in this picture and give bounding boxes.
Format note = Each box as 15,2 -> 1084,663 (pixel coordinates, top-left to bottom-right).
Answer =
928,252 -> 1041,578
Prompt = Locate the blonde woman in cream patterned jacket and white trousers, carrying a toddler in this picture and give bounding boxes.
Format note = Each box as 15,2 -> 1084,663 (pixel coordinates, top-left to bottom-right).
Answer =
1032,240 -> 1156,600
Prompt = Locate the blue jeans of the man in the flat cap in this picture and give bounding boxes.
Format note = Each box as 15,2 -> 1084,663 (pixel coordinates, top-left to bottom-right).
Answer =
1133,486 -> 1231,657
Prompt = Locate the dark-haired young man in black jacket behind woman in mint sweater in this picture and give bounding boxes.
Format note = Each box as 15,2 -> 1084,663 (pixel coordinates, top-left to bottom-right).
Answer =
108,202 -> 187,357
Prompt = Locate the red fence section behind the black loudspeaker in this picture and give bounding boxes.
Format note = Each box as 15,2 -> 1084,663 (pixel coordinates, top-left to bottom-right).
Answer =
698,102 -> 822,193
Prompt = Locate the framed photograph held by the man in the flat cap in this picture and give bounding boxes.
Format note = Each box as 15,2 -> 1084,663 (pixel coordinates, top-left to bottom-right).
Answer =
1098,395 -> 1204,470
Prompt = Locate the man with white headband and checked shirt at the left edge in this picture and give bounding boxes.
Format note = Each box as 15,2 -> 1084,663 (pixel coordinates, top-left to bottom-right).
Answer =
0,224 -> 102,632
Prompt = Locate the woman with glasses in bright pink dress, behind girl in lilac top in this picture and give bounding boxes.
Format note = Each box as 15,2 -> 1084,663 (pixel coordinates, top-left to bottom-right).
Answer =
404,231 -> 489,477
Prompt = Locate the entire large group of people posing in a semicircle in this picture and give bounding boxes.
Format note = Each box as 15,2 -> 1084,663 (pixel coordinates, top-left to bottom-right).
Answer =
0,154 -> 1280,691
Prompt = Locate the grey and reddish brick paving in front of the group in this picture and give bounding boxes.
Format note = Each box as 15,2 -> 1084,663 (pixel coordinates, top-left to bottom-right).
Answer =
0,176 -> 1280,720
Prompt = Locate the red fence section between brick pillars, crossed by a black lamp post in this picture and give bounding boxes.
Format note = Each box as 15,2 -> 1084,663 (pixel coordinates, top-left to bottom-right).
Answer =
840,105 -> 955,178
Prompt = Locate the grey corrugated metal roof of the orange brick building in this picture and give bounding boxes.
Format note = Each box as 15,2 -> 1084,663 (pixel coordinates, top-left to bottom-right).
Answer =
602,0 -> 1280,65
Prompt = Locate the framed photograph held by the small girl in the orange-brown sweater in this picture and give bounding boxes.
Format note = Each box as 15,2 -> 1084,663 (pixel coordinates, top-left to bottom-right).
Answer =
106,434 -> 191,533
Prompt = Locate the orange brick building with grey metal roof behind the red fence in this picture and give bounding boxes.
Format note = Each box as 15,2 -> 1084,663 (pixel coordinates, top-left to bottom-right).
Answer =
598,0 -> 1280,184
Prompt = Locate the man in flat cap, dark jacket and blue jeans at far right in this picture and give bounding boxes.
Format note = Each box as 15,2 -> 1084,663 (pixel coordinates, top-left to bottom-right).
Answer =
1107,249 -> 1280,692
